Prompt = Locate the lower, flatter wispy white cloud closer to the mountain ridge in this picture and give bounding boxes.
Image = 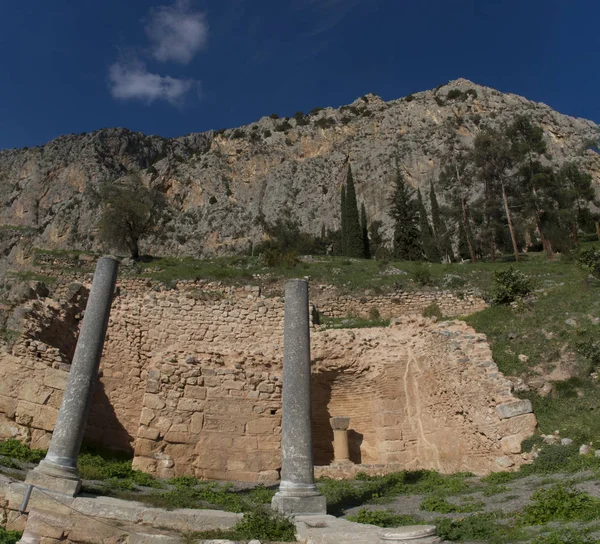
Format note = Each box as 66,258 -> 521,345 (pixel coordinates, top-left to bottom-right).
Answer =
108,61 -> 200,105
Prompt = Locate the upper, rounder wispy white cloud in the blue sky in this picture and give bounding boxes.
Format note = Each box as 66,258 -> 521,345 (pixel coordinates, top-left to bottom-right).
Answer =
145,0 -> 208,64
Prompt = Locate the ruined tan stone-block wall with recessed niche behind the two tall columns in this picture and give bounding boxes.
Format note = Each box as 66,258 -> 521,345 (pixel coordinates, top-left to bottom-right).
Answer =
0,279 -> 535,481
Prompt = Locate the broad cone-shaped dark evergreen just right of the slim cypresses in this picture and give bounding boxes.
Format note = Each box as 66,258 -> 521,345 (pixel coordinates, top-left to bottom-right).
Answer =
390,169 -> 423,261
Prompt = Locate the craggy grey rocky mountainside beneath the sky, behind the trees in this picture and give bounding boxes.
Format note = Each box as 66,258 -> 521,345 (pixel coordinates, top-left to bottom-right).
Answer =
0,79 -> 600,256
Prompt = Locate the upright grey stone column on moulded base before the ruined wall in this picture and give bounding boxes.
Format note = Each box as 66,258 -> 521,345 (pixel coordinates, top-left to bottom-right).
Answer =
272,280 -> 327,514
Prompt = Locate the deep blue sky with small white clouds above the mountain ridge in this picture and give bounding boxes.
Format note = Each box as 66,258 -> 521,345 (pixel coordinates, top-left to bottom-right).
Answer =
0,0 -> 600,149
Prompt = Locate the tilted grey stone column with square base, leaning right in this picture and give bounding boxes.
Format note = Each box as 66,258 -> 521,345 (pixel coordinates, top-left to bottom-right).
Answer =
26,257 -> 119,496
